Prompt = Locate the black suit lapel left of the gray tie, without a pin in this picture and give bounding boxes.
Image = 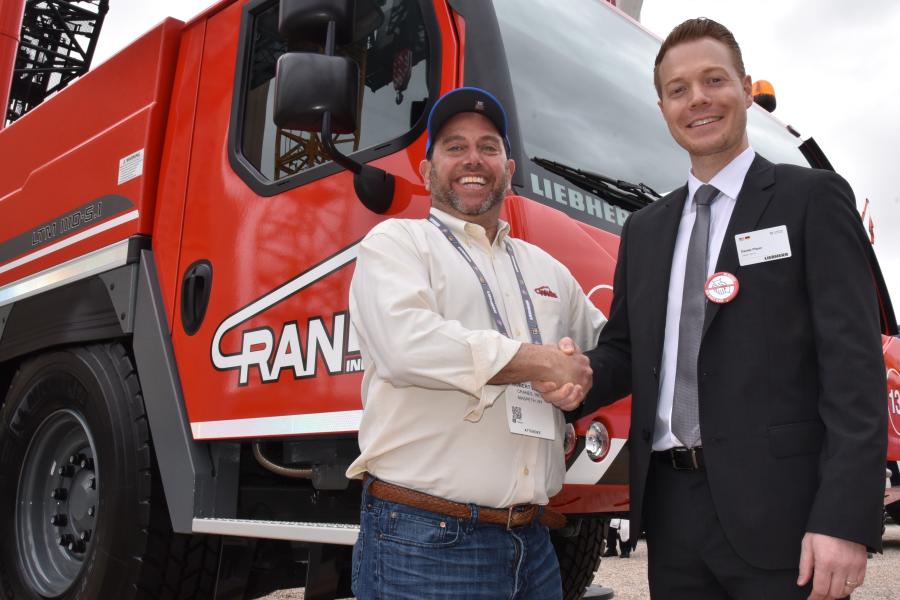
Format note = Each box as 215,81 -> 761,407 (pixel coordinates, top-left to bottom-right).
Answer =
645,186 -> 687,365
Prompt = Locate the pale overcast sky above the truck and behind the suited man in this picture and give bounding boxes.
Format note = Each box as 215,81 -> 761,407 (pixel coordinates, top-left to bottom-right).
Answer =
95,0 -> 900,304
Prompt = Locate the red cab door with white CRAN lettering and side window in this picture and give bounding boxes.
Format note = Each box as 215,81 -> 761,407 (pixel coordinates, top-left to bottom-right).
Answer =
172,0 -> 442,439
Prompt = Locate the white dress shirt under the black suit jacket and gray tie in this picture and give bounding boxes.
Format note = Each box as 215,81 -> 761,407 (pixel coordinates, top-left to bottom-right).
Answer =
653,148 -> 756,450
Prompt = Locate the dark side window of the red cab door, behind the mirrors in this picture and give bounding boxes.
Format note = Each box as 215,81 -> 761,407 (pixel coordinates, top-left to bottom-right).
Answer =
236,0 -> 431,182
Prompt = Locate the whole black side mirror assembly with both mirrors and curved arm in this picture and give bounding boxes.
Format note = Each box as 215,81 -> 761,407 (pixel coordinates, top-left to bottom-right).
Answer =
274,0 -> 394,214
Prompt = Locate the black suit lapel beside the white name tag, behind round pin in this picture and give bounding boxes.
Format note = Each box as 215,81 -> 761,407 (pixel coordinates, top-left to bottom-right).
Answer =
701,154 -> 775,339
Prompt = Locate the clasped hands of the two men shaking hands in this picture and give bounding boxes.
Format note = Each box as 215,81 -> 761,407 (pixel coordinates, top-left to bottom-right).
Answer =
531,337 -> 594,411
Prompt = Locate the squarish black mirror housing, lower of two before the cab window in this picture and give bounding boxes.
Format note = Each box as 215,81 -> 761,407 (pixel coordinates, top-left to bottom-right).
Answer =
273,52 -> 359,133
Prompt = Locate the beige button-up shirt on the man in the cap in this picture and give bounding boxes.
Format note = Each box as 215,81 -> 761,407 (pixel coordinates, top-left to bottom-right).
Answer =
347,208 -> 606,508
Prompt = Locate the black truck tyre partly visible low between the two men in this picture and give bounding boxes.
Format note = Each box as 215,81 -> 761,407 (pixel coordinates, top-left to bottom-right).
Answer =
551,518 -> 606,600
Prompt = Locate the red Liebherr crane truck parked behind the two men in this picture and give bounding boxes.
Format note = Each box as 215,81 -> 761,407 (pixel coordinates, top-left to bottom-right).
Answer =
0,0 -> 900,599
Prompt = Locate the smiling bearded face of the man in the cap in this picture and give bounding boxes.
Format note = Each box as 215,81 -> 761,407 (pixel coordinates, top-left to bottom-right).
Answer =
420,112 -> 515,220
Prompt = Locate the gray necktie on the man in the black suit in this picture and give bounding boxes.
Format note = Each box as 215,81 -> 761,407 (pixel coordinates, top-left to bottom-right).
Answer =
672,184 -> 719,448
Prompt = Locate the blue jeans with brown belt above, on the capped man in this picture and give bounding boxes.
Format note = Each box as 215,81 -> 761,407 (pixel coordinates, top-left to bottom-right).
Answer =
353,485 -> 562,600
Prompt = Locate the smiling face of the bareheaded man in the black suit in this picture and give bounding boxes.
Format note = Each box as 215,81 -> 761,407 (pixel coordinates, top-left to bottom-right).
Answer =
659,38 -> 753,177
